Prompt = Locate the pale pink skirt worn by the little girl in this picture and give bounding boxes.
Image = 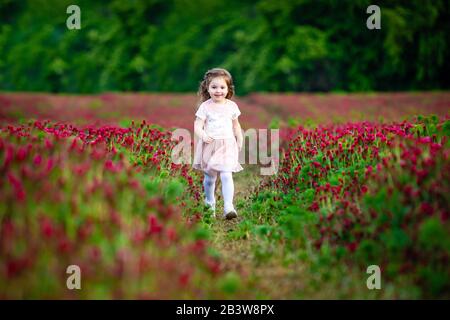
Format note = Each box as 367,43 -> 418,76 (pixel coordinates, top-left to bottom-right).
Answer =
193,137 -> 244,173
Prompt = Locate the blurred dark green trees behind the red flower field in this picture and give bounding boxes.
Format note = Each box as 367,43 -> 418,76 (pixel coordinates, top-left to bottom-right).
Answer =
0,0 -> 450,94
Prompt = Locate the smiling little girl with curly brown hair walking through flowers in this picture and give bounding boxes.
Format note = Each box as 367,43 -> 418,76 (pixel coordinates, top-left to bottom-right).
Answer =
193,68 -> 243,219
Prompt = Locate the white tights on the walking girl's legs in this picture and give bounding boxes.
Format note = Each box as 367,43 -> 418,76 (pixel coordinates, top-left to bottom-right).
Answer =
203,171 -> 234,213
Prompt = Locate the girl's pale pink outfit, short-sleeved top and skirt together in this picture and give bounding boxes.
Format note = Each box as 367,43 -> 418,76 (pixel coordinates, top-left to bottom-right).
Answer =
193,99 -> 244,173
